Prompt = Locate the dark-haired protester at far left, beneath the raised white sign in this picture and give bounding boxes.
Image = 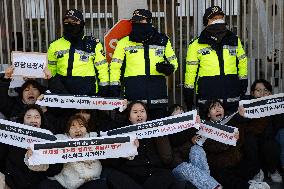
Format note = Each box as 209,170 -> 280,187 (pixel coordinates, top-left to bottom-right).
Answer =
0,80 -> 44,121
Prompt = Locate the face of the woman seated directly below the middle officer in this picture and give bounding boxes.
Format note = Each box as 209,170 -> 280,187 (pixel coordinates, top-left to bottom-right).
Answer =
129,103 -> 147,124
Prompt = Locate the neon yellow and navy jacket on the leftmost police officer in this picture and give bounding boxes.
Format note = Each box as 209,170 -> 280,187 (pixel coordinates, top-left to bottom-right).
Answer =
48,36 -> 109,95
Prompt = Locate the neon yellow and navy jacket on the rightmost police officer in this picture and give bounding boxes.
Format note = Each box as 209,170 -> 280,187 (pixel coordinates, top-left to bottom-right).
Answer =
184,31 -> 247,101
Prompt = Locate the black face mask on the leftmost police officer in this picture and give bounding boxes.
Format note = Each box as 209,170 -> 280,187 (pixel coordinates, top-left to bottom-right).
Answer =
63,23 -> 84,42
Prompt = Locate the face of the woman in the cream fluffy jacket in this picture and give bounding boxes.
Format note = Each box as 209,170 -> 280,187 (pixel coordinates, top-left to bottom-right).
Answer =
69,119 -> 87,138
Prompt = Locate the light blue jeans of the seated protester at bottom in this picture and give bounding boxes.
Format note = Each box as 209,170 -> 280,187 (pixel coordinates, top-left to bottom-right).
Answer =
173,145 -> 221,189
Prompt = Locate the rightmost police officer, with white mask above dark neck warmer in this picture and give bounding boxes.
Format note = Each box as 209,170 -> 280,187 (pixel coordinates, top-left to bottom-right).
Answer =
184,6 -> 247,113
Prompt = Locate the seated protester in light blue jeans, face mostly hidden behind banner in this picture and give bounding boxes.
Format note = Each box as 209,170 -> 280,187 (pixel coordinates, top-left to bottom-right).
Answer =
161,104 -> 221,189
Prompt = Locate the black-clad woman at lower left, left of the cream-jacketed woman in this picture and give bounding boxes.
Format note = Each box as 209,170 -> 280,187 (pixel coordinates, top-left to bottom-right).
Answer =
0,104 -> 62,189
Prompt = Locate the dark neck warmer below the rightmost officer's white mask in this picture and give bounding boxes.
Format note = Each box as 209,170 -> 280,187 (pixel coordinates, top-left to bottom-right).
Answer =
205,23 -> 228,43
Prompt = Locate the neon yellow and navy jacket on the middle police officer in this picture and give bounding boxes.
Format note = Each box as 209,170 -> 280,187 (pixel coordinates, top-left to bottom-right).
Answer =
110,33 -> 178,104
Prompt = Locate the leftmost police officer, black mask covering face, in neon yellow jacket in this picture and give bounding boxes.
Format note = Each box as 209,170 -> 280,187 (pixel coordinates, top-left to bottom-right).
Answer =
48,9 -> 109,96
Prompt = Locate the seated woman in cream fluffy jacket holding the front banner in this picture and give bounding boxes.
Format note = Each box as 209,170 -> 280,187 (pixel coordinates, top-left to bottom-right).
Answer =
27,115 -> 107,189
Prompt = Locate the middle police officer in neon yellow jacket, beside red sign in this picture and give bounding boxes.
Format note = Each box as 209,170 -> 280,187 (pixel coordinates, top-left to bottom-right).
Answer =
110,9 -> 178,119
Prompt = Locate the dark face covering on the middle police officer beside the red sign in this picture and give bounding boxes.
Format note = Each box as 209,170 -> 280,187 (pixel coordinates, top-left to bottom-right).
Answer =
129,23 -> 155,43
